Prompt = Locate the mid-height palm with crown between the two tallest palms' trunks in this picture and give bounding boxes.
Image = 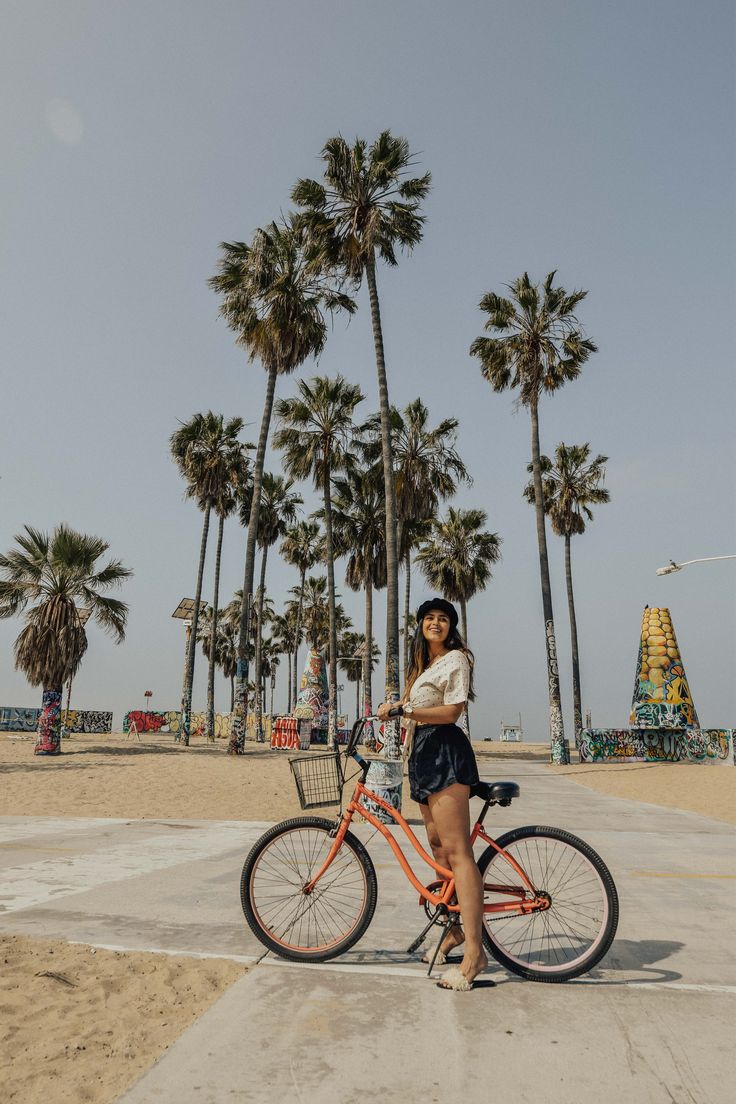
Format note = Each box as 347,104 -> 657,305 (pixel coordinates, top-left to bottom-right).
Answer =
274,375 -> 363,747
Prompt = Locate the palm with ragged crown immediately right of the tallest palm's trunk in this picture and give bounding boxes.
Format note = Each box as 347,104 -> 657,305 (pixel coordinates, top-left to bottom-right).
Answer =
363,399 -> 472,678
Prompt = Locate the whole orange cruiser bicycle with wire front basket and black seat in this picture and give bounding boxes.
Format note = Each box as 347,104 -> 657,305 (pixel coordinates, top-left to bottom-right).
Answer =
241,718 -> 618,981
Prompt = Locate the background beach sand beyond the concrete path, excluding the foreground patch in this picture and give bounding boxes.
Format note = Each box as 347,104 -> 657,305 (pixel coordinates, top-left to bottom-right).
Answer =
0,734 -> 736,824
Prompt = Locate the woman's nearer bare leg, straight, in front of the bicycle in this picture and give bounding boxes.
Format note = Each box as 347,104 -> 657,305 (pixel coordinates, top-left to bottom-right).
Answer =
428,783 -> 488,981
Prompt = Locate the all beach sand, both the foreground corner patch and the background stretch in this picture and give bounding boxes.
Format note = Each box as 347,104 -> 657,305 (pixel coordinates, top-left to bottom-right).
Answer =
0,734 -> 736,1104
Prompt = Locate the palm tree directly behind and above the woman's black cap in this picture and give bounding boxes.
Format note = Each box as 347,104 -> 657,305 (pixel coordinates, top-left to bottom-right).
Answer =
417,506 -> 502,641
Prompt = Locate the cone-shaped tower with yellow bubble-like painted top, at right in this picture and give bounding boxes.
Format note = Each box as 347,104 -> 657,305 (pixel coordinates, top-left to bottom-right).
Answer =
629,606 -> 700,729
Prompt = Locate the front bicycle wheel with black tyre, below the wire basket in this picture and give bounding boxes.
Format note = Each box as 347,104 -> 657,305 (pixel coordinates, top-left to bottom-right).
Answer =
241,817 -> 378,963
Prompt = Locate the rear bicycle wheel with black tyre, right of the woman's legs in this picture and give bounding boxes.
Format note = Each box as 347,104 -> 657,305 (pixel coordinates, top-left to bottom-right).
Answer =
478,826 -> 618,981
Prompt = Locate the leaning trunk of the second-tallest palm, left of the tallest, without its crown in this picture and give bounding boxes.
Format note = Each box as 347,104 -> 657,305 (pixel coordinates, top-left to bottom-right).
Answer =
227,364 -> 278,755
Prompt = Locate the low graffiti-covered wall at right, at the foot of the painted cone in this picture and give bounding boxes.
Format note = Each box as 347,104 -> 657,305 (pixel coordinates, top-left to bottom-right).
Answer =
577,729 -> 736,766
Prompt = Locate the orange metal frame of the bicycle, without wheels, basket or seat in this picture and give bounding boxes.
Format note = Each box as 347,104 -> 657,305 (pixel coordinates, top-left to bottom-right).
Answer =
303,737 -> 550,915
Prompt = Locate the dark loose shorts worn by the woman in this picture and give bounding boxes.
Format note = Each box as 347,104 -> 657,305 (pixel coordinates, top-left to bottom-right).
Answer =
409,724 -> 479,805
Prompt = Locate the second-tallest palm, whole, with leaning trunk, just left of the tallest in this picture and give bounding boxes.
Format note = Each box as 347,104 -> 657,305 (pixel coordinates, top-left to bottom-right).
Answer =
210,219 -> 355,754
